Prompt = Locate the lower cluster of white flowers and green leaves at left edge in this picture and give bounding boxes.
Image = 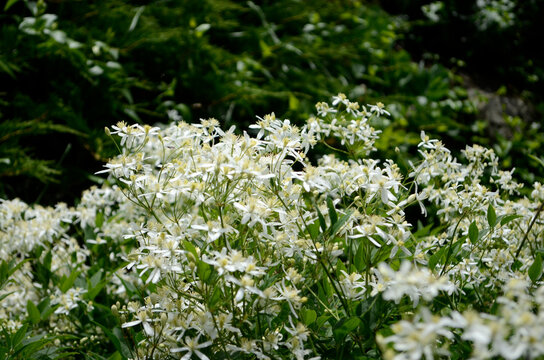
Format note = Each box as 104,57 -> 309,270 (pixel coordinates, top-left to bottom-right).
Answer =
0,186 -> 144,353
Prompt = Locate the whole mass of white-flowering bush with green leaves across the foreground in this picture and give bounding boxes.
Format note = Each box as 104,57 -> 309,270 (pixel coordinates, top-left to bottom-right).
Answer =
0,94 -> 544,359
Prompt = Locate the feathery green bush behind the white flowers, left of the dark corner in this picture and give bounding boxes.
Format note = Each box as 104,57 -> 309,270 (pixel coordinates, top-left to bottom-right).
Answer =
0,0 -> 484,204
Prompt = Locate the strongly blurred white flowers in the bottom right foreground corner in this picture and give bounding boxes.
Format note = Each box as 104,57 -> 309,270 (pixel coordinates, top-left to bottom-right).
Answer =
378,279 -> 544,360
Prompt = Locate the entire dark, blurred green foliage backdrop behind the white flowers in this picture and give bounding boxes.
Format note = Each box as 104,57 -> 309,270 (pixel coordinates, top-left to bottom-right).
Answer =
0,0 -> 544,205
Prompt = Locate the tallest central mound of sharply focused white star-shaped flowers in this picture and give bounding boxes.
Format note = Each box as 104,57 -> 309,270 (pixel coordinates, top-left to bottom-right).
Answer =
94,94 -> 409,359
